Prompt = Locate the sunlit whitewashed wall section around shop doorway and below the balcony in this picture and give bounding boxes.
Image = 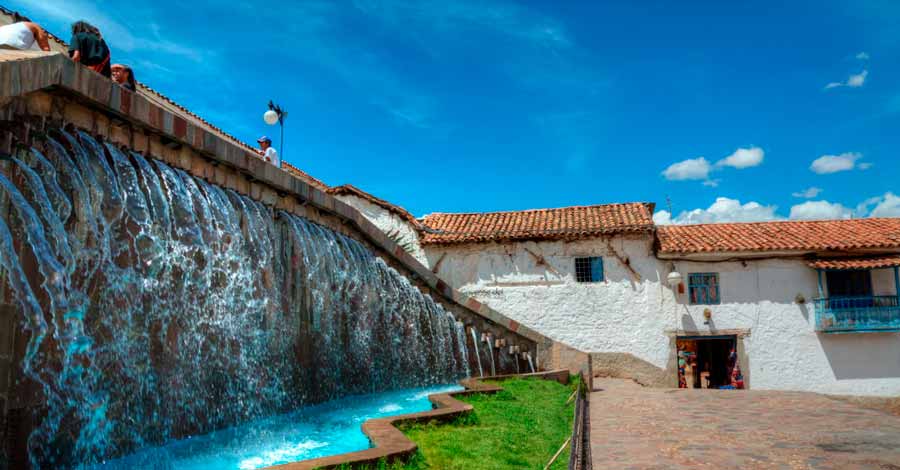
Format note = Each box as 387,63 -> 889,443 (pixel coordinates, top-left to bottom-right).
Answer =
666,260 -> 900,395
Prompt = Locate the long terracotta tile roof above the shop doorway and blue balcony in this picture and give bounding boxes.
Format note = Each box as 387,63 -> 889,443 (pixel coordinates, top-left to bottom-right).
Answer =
656,218 -> 900,254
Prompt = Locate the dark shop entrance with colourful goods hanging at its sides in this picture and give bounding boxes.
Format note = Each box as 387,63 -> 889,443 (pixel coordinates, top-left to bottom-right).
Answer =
676,335 -> 744,389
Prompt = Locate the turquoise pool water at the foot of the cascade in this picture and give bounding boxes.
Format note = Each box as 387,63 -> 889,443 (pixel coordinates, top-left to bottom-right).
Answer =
96,385 -> 462,470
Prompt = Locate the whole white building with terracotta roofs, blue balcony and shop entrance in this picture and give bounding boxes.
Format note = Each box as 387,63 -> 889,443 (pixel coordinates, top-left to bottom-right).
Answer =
342,188 -> 900,395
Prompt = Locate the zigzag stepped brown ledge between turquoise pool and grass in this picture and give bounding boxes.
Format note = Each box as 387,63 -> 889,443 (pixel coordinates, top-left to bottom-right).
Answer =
268,369 -> 569,470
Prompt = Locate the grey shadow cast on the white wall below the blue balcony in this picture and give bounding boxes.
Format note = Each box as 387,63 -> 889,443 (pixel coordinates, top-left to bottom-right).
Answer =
818,333 -> 900,380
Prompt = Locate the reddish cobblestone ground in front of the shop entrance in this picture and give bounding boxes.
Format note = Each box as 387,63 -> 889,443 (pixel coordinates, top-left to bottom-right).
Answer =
590,379 -> 900,470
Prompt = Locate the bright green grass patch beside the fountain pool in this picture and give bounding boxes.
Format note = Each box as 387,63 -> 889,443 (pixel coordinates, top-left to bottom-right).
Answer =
396,379 -> 577,470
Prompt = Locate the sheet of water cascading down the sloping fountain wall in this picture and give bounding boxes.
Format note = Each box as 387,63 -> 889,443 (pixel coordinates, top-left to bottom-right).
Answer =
0,131 -> 480,467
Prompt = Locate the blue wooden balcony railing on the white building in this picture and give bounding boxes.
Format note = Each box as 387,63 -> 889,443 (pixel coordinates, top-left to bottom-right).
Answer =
815,295 -> 900,333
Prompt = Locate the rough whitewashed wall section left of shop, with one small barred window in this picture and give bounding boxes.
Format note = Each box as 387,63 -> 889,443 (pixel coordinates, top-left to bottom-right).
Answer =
425,237 -> 675,367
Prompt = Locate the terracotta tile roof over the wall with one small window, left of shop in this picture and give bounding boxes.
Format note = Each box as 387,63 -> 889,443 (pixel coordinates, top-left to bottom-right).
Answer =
422,202 -> 654,245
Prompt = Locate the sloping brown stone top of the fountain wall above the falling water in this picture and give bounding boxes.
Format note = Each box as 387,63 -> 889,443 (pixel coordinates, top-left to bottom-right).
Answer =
0,52 -> 576,460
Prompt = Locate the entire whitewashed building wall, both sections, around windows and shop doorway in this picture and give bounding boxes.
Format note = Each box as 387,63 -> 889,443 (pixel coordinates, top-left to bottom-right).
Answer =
426,237 -> 900,395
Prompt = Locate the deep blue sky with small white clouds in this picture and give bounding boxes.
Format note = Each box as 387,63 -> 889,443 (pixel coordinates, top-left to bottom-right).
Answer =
7,0 -> 900,223
